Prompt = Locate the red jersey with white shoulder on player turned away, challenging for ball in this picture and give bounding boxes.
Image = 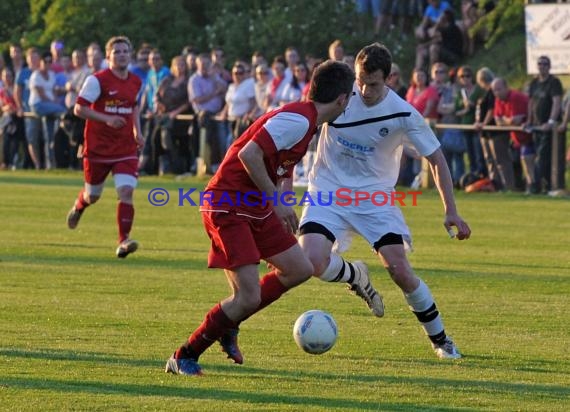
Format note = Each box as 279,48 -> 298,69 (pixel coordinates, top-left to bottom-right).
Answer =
201,102 -> 317,216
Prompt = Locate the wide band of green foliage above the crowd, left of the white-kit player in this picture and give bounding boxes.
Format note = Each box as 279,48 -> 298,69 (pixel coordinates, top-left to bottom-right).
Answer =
0,0 -> 361,59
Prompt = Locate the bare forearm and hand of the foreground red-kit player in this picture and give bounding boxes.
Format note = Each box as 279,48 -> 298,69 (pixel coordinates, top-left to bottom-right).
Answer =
238,141 -> 299,233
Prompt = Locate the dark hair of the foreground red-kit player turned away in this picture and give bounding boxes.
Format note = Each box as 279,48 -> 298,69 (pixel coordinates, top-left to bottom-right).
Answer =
309,60 -> 354,103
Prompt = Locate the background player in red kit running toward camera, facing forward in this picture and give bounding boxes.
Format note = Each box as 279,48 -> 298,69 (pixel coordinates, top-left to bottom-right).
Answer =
67,36 -> 144,258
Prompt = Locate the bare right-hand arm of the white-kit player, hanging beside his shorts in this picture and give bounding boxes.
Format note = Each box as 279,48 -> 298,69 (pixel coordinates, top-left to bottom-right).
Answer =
426,148 -> 471,240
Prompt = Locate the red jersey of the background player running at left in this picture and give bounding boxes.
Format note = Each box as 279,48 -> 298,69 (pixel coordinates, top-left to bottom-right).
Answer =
77,69 -> 142,160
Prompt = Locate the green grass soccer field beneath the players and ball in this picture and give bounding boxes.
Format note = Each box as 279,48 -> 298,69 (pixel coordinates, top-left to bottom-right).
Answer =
0,171 -> 570,411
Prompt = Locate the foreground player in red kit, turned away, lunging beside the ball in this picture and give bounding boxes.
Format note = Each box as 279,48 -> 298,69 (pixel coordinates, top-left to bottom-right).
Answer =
166,61 -> 354,375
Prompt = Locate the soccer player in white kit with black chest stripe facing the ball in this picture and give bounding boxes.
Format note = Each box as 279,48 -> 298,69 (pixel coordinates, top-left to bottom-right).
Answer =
299,43 -> 471,359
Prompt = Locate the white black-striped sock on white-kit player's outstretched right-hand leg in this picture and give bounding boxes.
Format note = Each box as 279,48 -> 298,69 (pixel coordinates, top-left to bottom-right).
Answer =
404,279 -> 446,344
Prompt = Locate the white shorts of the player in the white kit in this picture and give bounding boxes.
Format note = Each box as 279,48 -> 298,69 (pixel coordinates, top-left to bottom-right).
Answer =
299,204 -> 412,253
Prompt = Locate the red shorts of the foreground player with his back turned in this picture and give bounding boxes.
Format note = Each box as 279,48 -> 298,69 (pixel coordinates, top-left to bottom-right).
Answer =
202,212 -> 297,270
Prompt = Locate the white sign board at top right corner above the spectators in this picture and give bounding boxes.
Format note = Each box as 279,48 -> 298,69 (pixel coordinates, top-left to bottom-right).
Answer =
525,4 -> 570,74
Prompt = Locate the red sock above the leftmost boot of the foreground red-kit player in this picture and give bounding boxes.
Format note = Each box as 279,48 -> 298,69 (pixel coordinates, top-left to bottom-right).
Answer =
174,303 -> 237,360
